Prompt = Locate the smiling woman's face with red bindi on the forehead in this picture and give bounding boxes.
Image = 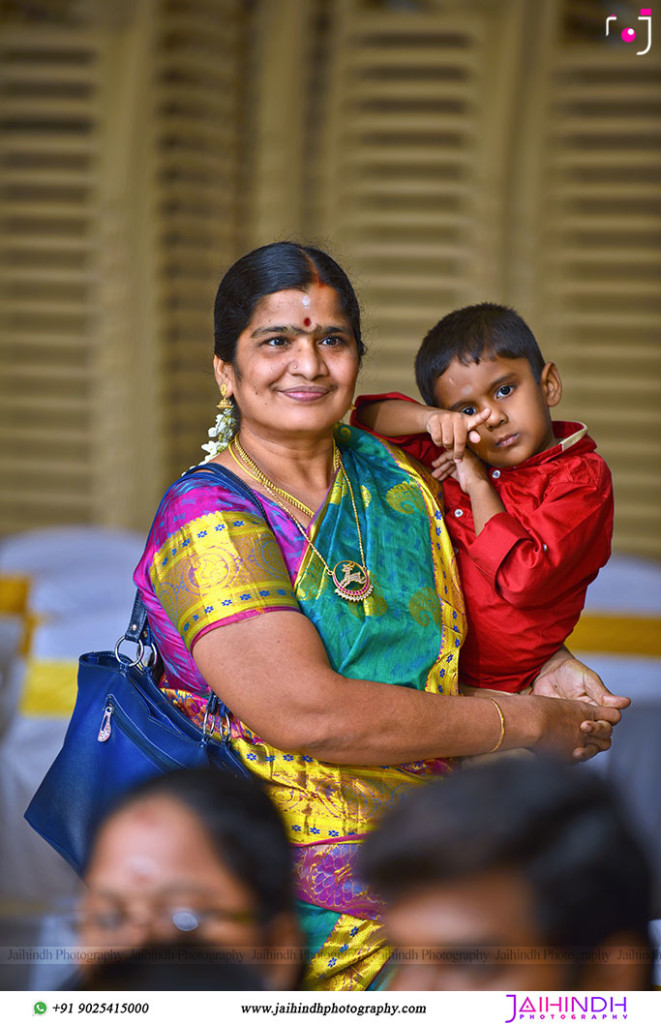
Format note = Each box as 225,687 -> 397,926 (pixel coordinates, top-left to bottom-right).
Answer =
214,284 -> 358,437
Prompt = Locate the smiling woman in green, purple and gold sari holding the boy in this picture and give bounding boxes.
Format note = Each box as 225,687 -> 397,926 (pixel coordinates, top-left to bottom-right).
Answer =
135,243 -> 619,989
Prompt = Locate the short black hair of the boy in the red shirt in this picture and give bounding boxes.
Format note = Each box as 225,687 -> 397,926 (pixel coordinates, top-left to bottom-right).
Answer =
415,302 -> 544,406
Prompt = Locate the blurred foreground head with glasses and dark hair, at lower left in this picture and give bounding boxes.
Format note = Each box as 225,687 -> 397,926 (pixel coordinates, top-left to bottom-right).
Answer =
80,768 -> 301,988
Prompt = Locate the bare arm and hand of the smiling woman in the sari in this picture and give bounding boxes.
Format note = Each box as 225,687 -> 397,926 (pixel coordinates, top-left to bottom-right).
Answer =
193,611 -> 620,765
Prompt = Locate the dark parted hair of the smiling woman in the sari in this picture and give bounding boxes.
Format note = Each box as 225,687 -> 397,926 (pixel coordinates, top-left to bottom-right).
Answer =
214,242 -> 365,362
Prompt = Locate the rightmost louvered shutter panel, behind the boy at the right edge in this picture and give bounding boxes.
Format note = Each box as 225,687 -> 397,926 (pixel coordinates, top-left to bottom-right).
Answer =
514,23 -> 661,558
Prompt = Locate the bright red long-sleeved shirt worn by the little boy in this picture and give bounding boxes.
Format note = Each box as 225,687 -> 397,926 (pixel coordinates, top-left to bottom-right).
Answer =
351,392 -> 613,692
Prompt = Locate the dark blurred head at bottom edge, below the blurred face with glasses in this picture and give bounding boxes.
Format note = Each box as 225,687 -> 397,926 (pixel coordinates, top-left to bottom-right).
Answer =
76,942 -> 266,992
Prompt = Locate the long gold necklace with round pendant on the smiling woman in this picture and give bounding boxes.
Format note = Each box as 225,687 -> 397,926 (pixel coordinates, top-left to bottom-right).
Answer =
228,437 -> 373,601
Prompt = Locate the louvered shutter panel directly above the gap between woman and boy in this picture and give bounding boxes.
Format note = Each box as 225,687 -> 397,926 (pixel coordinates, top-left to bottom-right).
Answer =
318,0 -> 521,390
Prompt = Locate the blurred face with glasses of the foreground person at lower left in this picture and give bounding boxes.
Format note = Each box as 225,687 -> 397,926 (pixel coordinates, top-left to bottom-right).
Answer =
81,797 -> 263,948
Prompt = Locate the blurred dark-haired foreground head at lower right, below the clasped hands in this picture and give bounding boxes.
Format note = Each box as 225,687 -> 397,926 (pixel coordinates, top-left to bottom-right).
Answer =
361,758 -> 651,990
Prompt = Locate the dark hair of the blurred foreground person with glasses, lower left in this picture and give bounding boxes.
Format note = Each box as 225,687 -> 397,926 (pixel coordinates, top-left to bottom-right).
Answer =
92,767 -> 294,924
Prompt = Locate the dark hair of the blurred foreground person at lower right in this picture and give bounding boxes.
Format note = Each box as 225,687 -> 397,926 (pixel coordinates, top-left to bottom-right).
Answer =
360,758 -> 652,962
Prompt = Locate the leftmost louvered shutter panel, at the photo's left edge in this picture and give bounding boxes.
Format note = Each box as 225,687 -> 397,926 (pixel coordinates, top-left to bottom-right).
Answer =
0,26 -> 100,530
